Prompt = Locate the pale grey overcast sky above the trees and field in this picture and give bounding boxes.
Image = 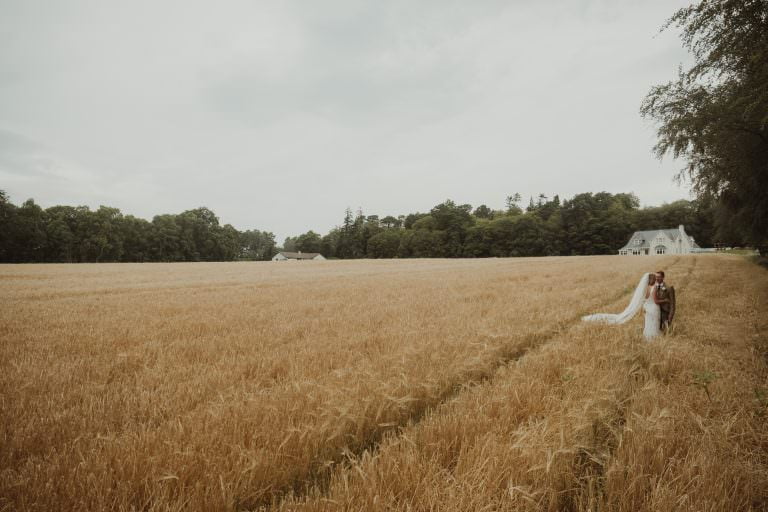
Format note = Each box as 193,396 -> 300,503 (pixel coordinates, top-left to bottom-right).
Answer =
0,0 -> 689,241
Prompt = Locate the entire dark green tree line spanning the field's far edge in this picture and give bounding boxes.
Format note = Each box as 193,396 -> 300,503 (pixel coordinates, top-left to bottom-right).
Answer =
0,191 -> 728,263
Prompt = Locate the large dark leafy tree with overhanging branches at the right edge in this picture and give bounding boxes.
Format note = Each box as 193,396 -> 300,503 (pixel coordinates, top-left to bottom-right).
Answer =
641,0 -> 768,252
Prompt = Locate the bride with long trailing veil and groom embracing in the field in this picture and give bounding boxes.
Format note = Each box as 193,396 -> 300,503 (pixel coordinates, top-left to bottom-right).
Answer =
581,270 -> 675,341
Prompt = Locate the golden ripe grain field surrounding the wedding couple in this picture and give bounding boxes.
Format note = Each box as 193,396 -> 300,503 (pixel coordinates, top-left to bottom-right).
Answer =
0,255 -> 768,512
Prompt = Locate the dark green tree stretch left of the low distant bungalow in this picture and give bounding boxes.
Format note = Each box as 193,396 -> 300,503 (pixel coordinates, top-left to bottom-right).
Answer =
0,190 -> 277,263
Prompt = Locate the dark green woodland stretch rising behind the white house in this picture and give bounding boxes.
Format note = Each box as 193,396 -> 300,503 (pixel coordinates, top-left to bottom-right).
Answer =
283,192 -> 728,259
